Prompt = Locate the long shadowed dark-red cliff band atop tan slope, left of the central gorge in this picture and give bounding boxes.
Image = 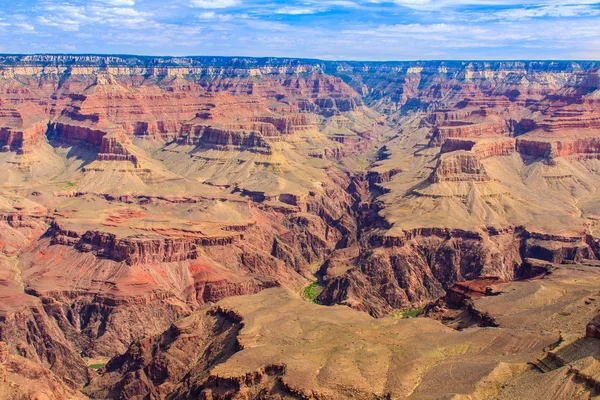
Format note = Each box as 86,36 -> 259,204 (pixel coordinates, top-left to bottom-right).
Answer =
177,124 -> 272,155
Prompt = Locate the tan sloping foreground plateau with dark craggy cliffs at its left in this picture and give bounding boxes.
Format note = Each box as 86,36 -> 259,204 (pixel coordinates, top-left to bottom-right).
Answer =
84,282 -> 598,400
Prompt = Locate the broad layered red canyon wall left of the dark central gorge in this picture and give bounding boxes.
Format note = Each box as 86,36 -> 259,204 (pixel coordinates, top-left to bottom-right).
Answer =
0,56 -> 376,386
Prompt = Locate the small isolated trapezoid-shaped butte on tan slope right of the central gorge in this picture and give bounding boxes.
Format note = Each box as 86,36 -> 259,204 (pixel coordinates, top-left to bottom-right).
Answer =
429,150 -> 491,183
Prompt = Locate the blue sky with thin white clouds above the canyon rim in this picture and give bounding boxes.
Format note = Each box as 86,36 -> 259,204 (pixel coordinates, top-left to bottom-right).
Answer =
0,0 -> 600,61
